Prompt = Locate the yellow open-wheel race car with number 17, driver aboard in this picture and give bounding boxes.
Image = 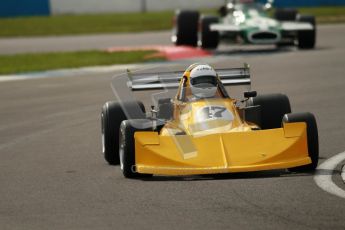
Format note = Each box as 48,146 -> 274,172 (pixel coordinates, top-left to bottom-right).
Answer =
102,64 -> 319,178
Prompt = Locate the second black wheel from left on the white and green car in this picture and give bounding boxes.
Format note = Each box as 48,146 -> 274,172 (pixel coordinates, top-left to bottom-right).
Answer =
201,16 -> 219,49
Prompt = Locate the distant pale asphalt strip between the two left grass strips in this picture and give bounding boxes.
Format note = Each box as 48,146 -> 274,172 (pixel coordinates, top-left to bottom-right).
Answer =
0,31 -> 171,54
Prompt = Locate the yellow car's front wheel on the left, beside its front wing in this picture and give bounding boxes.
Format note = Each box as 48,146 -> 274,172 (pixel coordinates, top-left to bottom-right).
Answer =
119,119 -> 152,178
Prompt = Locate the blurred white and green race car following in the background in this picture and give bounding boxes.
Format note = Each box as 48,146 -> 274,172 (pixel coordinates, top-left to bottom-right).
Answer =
172,0 -> 316,49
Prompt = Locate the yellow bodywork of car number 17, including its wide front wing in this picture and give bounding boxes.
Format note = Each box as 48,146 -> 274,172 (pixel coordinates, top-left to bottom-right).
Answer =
134,64 -> 311,175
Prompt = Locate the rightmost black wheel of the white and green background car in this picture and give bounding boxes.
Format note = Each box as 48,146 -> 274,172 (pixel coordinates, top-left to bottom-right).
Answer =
297,15 -> 316,49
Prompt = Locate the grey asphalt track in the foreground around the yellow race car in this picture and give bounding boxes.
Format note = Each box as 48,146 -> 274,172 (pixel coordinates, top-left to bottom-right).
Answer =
0,25 -> 345,229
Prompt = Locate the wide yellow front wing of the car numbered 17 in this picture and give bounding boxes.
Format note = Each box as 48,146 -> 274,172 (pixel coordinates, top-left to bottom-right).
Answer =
135,122 -> 311,175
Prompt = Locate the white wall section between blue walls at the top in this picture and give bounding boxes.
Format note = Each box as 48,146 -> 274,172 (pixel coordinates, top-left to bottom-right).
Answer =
50,0 -> 224,14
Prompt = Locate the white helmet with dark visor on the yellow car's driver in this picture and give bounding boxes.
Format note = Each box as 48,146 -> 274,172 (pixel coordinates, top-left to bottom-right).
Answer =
190,64 -> 218,98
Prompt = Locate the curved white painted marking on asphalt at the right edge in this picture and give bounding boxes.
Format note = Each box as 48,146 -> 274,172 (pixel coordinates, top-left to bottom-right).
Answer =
314,152 -> 345,199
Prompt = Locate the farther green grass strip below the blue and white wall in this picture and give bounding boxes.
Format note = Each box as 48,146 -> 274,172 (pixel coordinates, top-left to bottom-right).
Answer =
0,6 -> 345,37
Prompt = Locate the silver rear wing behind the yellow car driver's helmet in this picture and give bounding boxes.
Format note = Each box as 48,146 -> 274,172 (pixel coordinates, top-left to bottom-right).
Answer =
127,64 -> 251,90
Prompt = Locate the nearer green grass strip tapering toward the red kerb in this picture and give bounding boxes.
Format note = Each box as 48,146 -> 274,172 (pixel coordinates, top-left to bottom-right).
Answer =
0,51 -> 163,74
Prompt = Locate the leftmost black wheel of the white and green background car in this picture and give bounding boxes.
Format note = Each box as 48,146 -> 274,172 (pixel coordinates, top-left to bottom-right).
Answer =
175,11 -> 199,47
